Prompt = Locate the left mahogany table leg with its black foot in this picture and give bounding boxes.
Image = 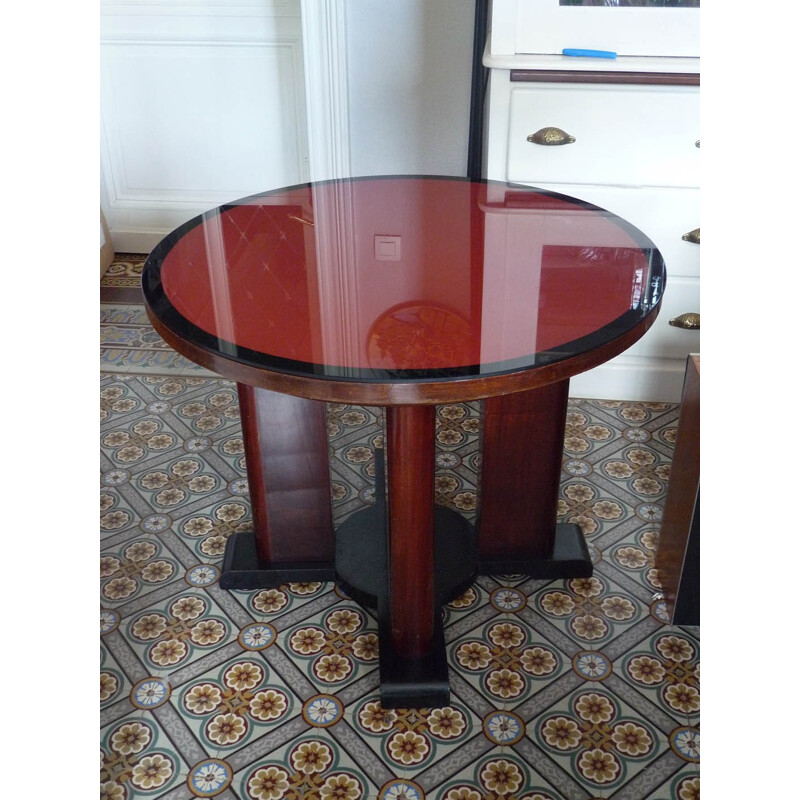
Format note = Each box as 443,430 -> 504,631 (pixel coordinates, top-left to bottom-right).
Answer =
220,384 -> 334,589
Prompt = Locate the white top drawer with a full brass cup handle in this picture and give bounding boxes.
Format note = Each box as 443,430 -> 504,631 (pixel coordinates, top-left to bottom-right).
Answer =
507,84 -> 700,187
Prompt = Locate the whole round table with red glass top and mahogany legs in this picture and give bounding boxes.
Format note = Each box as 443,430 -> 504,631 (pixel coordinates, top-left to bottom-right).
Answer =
142,176 -> 666,707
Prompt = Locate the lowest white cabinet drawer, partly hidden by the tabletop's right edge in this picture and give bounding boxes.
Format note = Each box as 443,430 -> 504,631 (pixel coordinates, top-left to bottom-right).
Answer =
625,273 -> 700,358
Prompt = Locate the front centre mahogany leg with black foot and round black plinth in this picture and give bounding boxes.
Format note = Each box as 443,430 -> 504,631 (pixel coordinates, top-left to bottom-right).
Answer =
336,406 -> 478,708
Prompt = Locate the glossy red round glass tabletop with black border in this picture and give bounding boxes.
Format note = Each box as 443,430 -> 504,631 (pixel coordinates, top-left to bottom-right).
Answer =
143,177 -> 664,381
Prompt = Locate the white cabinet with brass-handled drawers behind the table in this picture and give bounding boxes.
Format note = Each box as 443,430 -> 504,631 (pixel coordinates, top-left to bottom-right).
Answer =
483,8 -> 700,402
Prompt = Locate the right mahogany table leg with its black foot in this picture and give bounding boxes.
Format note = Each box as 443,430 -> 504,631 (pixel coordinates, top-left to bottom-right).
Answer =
478,380 -> 592,578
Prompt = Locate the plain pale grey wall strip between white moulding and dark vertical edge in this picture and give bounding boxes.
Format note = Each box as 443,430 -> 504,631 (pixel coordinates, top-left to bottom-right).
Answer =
347,0 -> 475,175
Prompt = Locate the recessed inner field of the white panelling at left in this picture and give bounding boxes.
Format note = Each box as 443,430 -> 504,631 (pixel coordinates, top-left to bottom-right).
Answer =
103,43 -> 303,201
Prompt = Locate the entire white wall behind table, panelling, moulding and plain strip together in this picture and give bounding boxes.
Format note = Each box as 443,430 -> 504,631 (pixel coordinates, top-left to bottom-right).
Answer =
100,0 -> 474,252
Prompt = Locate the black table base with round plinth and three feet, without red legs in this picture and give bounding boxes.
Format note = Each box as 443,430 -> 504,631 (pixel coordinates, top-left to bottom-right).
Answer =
220,510 -> 592,708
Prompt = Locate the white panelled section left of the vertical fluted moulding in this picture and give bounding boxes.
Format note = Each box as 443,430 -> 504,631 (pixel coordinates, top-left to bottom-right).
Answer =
100,0 -> 312,252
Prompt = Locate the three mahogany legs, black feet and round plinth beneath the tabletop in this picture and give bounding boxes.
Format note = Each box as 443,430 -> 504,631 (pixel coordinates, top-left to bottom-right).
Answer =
220,381 -> 592,708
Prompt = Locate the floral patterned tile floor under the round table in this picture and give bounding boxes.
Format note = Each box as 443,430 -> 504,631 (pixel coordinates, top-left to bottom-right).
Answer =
100,256 -> 700,800
